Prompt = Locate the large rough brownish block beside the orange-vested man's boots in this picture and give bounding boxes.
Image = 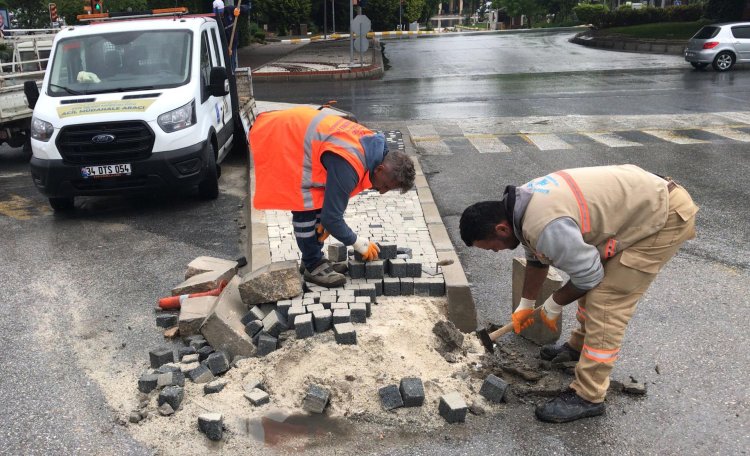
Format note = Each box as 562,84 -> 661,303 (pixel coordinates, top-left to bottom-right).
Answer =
239,260 -> 303,307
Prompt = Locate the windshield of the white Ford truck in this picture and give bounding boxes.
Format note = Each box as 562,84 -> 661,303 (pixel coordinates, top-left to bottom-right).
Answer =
47,30 -> 192,97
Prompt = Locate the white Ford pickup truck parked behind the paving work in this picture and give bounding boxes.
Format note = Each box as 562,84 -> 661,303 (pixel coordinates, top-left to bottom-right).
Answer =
26,15 -> 255,211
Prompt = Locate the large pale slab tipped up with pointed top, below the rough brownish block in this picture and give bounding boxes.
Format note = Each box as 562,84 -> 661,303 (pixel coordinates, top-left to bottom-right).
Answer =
201,277 -> 255,359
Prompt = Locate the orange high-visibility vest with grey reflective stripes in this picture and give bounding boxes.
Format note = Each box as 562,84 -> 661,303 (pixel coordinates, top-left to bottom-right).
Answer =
249,107 -> 375,211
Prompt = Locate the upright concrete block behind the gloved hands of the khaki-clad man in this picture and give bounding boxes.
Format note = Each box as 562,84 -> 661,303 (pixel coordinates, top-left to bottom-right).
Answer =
511,257 -> 563,345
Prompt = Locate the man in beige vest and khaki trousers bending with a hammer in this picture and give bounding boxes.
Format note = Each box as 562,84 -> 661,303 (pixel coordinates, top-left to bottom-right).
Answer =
460,165 -> 698,422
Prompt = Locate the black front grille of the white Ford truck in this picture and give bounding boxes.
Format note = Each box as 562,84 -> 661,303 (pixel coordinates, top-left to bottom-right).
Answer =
56,121 -> 154,165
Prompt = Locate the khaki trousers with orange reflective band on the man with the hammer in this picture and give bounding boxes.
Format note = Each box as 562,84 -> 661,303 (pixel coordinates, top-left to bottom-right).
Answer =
568,186 -> 698,403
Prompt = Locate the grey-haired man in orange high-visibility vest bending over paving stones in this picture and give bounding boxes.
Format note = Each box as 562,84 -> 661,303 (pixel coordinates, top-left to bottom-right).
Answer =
249,107 -> 415,288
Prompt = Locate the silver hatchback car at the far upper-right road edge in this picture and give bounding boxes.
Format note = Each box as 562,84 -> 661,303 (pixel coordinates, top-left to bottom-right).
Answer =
685,22 -> 750,71
